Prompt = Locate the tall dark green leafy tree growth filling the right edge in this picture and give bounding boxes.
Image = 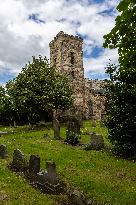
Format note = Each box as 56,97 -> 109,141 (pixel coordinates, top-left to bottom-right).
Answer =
104,0 -> 136,157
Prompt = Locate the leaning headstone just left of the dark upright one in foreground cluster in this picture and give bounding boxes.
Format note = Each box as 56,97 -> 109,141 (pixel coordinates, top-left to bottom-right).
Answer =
11,149 -> 27,171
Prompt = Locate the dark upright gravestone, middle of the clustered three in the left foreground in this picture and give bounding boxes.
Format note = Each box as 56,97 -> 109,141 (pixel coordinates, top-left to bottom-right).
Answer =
29,155 -> 40,174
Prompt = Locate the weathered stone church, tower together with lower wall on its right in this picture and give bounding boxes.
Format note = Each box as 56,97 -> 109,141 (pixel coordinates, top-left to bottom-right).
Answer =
49,31 -> 105,120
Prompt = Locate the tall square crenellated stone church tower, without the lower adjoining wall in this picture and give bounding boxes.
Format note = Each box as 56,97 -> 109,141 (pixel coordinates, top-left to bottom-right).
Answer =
49,31 -> 85,115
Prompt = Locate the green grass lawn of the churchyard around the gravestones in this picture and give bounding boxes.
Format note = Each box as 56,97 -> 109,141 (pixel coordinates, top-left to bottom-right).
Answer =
0,121 -> 136,205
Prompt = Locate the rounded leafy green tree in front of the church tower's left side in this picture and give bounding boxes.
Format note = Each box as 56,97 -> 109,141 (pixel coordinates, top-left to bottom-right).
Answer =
6,56 -> 73,124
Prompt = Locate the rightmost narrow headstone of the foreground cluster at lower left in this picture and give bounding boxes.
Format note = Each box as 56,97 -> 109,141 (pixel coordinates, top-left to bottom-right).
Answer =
46,161 -> 58,185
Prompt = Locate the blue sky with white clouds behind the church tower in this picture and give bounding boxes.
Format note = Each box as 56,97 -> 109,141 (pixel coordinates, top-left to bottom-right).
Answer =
0,0 -> 119,85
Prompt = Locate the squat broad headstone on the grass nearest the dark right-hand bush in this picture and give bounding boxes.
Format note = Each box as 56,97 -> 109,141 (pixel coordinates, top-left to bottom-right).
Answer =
85,133 -> 104,150
